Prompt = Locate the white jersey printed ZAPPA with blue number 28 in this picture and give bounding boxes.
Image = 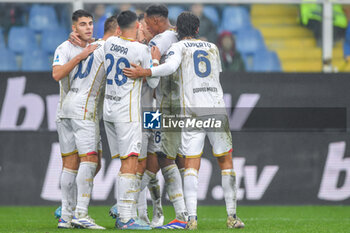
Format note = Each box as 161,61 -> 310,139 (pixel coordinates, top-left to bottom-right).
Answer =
103,37 -> 152,122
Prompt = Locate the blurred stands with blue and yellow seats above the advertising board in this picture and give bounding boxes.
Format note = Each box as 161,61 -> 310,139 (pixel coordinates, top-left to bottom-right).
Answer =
0,0 -> 350,72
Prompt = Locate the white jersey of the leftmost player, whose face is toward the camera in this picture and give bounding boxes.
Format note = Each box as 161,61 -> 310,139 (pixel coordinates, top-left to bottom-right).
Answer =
52,41 -> 84,118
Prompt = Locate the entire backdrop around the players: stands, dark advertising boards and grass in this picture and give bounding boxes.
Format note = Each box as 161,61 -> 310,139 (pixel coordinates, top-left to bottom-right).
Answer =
0,0 -> 350,232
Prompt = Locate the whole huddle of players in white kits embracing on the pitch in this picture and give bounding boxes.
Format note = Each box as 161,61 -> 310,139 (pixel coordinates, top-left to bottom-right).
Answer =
52,4 -> 244,230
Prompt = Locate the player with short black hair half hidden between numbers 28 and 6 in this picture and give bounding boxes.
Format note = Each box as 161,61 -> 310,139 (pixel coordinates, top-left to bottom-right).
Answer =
141,4 -> 187,229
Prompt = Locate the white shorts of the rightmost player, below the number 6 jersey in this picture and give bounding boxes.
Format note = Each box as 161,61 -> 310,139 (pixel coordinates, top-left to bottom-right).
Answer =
179,117 -> 232,158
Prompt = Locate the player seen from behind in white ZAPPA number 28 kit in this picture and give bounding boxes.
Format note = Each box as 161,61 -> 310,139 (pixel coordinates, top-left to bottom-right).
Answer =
103,11 -> 159,230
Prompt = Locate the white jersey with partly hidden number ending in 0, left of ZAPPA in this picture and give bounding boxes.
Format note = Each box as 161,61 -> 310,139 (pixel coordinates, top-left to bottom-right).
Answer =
60,40 -> 106,121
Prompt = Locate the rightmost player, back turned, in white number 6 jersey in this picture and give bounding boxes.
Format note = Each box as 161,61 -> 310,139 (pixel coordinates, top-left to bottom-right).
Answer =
124,12 -> 244,229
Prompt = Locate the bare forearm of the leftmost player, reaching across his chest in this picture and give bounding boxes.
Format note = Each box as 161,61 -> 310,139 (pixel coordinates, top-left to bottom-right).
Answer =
52,44 -> 98,81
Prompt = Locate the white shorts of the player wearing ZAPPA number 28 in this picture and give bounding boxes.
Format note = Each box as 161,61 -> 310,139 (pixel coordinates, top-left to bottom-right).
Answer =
104,121 -> 142,159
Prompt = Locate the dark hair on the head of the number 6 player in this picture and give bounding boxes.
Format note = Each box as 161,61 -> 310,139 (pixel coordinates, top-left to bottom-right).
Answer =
176,11 -> 199,40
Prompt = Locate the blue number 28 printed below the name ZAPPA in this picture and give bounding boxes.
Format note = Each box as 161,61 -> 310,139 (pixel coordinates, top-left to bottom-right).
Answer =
106,54 -> 130,86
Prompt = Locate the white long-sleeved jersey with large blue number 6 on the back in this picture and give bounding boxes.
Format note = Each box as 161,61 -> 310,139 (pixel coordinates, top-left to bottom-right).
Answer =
151,39 -> 225,115
